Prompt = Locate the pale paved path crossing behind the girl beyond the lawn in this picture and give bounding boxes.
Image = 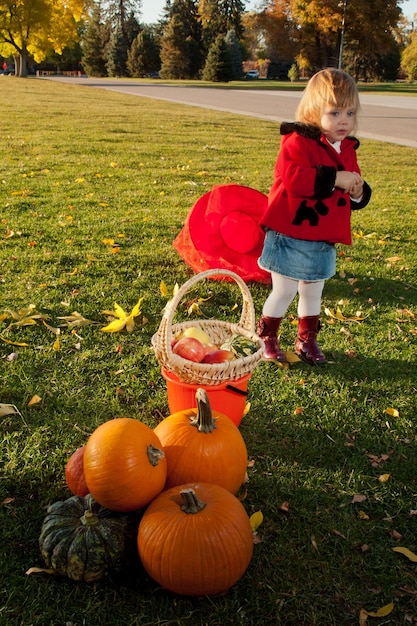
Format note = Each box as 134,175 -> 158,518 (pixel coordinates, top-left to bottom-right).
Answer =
45,76 -> 417,148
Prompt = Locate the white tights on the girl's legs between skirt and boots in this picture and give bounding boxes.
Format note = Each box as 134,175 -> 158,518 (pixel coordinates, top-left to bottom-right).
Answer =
262,272 -> 324,317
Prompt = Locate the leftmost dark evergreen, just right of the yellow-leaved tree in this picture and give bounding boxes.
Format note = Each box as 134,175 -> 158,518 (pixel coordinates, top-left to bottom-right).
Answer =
81,2 -> 111,76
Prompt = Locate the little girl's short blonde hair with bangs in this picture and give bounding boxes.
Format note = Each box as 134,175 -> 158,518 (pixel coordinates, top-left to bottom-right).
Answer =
295,68 -> 360,130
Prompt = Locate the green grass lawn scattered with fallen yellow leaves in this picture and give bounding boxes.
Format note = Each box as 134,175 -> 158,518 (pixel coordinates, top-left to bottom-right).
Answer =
0,77 -> 417,626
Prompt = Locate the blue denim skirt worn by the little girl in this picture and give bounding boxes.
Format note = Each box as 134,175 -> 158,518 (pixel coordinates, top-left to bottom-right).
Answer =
258,230 -> 336,281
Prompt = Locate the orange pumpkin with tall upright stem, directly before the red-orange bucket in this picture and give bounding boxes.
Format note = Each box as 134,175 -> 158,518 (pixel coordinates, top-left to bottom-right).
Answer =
154,388 -> 248,493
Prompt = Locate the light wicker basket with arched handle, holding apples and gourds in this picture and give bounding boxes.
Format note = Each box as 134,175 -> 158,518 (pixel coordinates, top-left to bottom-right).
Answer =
152,269 -> 264,386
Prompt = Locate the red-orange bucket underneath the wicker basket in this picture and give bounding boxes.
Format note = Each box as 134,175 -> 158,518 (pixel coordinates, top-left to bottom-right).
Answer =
161,368 -> 252,426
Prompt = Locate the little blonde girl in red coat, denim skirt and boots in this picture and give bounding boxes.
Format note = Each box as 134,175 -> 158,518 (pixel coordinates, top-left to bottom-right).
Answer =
257,69 -> 371,364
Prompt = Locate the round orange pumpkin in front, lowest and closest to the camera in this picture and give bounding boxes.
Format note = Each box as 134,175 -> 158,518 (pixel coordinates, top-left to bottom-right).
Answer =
138,483 -> 253,596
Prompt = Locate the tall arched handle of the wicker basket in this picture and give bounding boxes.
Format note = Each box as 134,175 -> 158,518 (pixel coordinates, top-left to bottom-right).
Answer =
161,269 -> 255,345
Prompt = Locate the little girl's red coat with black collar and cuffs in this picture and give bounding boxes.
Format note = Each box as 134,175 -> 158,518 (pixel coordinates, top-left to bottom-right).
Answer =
261,123 -> 371,244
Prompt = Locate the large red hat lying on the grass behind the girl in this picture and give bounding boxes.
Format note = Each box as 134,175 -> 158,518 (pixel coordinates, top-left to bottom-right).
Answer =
173,184 -> 271,284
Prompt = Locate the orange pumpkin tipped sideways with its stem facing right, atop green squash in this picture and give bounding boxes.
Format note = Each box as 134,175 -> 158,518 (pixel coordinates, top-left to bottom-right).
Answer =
84,417 -> 167,512
